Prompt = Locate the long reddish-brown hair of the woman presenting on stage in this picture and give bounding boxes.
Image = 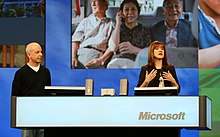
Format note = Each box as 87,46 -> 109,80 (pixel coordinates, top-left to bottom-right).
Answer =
148,41 -> 168,67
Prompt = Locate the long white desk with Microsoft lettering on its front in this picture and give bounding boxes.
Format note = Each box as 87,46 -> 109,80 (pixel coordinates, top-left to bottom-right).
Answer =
11,96 -> 212,129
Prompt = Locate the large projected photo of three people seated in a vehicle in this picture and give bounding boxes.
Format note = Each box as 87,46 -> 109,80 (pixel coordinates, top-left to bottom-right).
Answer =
71,0 -> 198,69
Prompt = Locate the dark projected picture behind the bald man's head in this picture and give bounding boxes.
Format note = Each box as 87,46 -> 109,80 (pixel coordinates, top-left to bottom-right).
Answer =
0,0 -> 45,68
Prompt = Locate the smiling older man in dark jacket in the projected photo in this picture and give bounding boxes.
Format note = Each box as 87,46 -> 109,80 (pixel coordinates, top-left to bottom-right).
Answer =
134,0 -> 199,68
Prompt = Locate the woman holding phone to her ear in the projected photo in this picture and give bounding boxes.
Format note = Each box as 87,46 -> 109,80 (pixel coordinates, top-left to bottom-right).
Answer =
87,0 -> 151,68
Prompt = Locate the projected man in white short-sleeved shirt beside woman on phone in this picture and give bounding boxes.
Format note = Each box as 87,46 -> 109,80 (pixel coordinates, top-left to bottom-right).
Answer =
72,0 -> 114,68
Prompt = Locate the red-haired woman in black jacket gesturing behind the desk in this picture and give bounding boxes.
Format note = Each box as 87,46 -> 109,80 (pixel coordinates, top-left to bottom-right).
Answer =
137,41 -> 180,94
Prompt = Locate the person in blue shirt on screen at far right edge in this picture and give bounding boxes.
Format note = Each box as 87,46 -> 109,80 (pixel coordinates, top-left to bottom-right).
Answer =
198,0 -> 220,68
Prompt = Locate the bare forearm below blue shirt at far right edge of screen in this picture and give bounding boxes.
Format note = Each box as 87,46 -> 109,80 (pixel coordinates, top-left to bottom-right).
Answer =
199,44 -> 220,68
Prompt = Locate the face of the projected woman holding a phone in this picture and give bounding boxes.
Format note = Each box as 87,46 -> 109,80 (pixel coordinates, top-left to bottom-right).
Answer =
122,2 -> 138,23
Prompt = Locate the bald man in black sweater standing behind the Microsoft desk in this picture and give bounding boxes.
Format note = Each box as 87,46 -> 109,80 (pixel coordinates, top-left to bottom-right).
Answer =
12,42 -> 51,137
